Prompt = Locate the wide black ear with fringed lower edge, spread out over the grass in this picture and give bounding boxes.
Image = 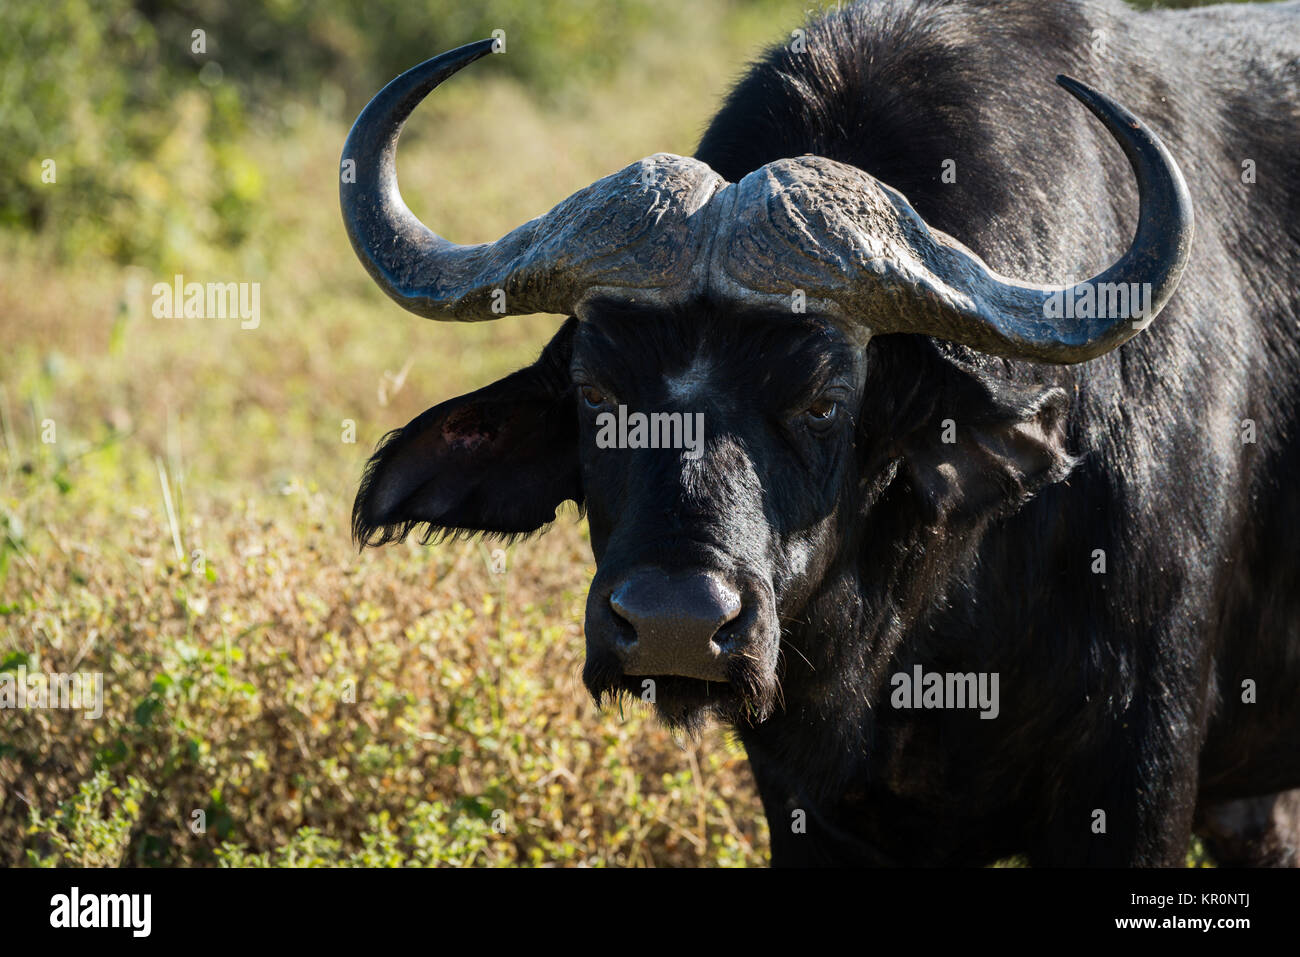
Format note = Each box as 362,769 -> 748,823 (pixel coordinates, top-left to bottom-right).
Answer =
352,319 -> 582,545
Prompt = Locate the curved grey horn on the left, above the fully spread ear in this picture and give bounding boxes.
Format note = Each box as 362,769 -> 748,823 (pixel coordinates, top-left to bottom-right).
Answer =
339,39 -> 723,321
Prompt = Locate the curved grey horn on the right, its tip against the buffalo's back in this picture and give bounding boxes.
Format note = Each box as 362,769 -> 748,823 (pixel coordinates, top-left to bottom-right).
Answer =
710,75 -> 1192,363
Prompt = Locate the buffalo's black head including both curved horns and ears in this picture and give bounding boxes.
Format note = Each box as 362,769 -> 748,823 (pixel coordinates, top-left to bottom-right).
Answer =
341,40 -> 1192,723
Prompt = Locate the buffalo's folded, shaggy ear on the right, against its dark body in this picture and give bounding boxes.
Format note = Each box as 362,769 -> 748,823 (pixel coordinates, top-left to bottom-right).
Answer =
902,367 -> 1078,521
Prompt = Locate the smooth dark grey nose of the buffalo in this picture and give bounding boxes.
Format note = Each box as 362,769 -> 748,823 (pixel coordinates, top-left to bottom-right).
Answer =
610,568 -> 741,681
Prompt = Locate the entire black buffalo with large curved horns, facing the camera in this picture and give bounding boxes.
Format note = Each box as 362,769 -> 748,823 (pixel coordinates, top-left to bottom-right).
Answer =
341,0 -> 1300,865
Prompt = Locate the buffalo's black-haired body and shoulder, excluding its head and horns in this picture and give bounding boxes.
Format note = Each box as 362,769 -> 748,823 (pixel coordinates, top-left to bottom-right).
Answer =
697,0 -> 1300,863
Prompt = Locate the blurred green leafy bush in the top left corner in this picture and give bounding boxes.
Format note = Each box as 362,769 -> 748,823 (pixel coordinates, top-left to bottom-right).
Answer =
0,0 -> 263,267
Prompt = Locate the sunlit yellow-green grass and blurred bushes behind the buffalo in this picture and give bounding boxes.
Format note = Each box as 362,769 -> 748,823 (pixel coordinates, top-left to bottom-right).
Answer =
0,0 -> 1237,866
